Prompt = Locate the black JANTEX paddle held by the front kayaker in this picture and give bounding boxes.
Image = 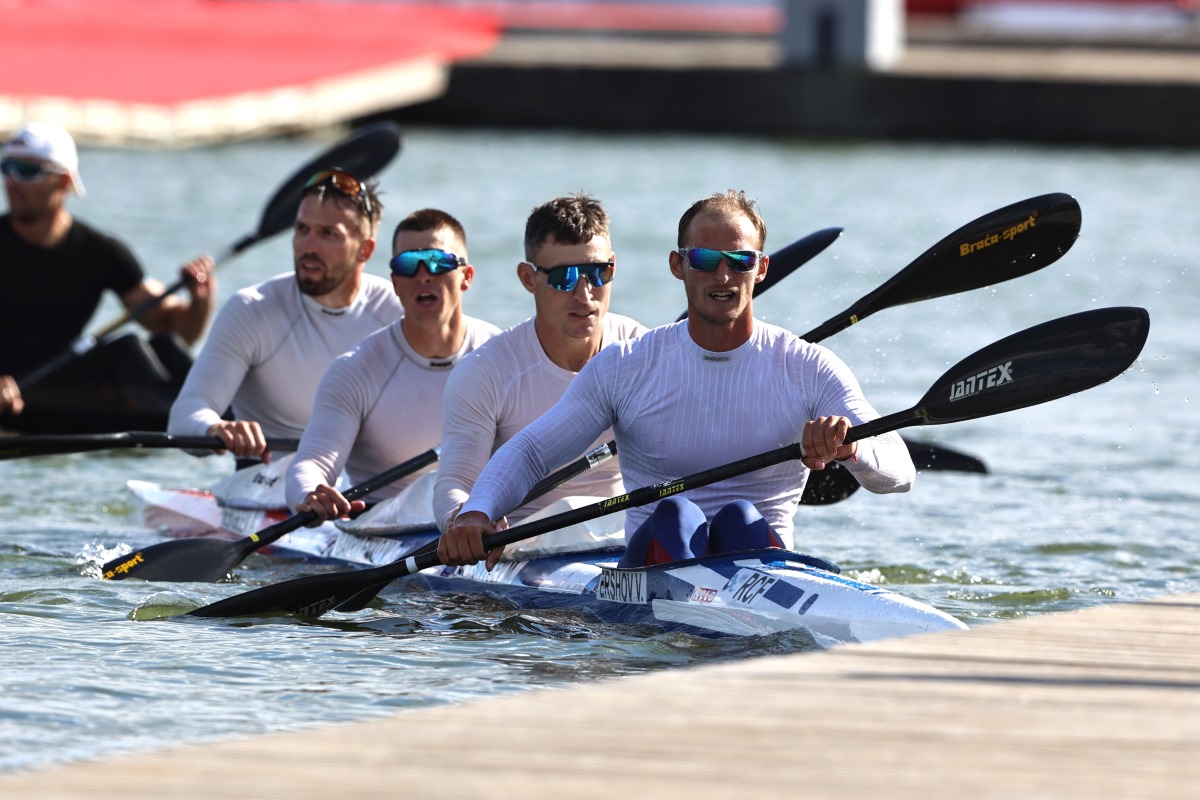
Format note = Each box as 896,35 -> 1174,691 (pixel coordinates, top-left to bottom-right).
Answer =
188,307 -> 1150,616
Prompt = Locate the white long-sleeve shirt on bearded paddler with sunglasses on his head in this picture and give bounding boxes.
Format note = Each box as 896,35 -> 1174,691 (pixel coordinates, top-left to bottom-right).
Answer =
167,272 -> 404,438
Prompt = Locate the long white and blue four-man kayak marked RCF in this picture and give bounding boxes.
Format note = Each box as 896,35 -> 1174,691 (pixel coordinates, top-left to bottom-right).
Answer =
130,481 -> 966,645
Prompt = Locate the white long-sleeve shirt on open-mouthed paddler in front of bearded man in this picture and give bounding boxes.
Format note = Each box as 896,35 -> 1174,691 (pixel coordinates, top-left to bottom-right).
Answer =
287,317 -> 500,507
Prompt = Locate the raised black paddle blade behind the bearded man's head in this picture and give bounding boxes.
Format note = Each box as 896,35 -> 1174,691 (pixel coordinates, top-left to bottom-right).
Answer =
253,122 -> 403,245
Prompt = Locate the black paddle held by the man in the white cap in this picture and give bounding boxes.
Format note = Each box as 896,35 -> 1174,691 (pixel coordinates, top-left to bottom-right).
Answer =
17,122 -> 402,390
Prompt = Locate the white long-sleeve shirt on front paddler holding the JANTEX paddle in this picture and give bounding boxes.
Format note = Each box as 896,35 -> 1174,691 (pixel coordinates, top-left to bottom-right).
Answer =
463,320 -> 916,547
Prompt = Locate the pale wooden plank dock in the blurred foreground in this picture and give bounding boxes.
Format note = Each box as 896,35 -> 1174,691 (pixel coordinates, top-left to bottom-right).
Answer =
0,594 -> 1200,800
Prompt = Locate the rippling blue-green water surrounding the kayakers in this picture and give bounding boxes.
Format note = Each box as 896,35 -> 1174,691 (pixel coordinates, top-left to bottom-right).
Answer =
0,128 -> 1200,771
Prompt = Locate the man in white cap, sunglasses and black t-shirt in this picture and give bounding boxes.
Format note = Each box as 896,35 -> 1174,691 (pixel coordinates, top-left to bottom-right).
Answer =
0,122 -> 215,429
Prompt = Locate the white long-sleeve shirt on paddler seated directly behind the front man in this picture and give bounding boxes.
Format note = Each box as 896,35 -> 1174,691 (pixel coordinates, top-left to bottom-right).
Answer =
433,313 -> 646,530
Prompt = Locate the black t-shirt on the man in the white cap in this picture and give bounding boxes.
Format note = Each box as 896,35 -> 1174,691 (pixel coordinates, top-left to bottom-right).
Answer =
0,213 -> 143,377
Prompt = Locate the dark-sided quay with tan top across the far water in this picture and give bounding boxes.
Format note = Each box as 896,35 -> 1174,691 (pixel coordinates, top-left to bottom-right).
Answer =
391,29 -> 1200,148
